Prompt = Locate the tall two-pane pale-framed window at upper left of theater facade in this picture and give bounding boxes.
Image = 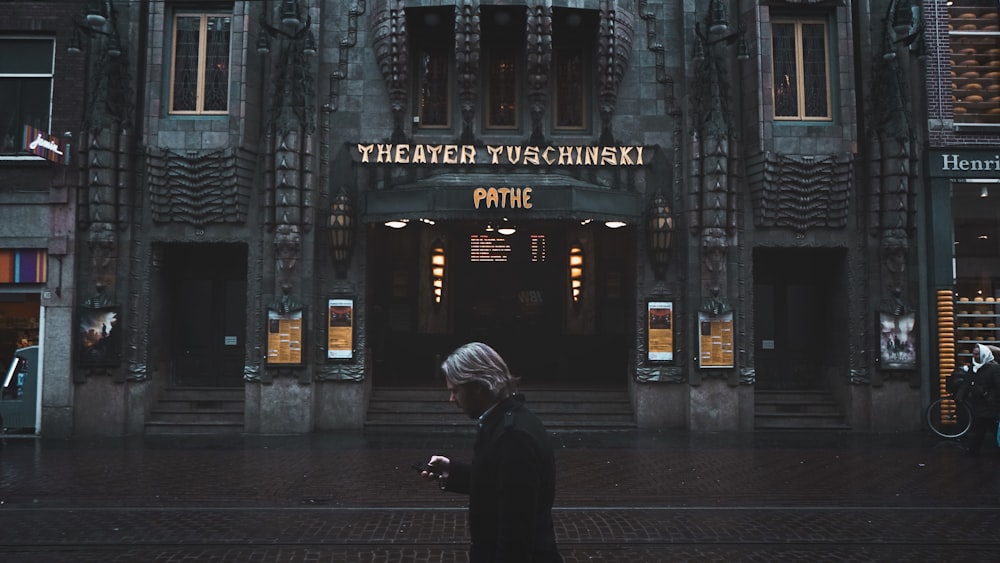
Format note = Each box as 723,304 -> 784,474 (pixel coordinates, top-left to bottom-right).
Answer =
170,13 -> 232,115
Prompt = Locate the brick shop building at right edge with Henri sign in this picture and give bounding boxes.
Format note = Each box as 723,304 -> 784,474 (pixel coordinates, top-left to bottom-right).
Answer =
921,0 -> 1000,418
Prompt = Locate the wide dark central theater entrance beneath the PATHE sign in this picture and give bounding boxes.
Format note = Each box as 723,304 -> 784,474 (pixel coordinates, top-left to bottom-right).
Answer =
367,220 -> 635,388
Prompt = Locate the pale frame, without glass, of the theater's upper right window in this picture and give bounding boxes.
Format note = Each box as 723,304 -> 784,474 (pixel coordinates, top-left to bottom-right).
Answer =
771,16 -> 834,123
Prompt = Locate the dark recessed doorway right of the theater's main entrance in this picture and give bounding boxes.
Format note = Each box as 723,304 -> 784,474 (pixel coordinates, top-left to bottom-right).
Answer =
753,248 -> 847,390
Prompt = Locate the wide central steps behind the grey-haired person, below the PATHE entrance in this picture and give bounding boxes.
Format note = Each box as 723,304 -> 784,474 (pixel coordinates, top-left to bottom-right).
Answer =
365,387 -> 636,432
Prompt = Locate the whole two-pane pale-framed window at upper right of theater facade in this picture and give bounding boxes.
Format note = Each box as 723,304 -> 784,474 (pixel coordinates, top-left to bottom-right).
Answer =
771,19 -> 832,121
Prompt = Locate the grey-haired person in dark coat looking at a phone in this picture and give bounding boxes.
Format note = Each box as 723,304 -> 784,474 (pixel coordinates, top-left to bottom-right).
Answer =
421,342 -> 562,563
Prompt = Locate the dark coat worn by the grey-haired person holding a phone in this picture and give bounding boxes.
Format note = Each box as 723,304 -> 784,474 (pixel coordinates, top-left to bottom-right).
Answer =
444,396 -> 562,563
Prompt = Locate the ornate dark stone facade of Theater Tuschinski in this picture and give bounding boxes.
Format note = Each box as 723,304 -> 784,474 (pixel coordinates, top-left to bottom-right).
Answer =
0,0 -> 948,436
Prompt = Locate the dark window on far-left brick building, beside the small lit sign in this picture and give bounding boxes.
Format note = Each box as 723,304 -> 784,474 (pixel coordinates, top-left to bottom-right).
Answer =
0,37 -> 55,156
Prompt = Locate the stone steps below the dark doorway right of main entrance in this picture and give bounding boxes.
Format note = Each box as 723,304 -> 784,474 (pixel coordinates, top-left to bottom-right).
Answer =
754,390 -> 851,430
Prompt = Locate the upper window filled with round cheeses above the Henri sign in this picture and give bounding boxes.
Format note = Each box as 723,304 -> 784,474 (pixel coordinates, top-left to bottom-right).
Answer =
948,0 -> 1000,124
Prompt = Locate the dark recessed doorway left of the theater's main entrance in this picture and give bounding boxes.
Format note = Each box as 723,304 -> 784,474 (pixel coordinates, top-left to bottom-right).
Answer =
164,244 -> 247,387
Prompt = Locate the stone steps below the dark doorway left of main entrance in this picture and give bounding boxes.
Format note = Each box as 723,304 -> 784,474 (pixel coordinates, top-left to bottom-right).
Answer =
145,387 -> 245,436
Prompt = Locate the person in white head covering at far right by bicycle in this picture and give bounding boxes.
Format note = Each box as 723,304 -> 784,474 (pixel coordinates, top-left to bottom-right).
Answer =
956,344 -> 1000,456
